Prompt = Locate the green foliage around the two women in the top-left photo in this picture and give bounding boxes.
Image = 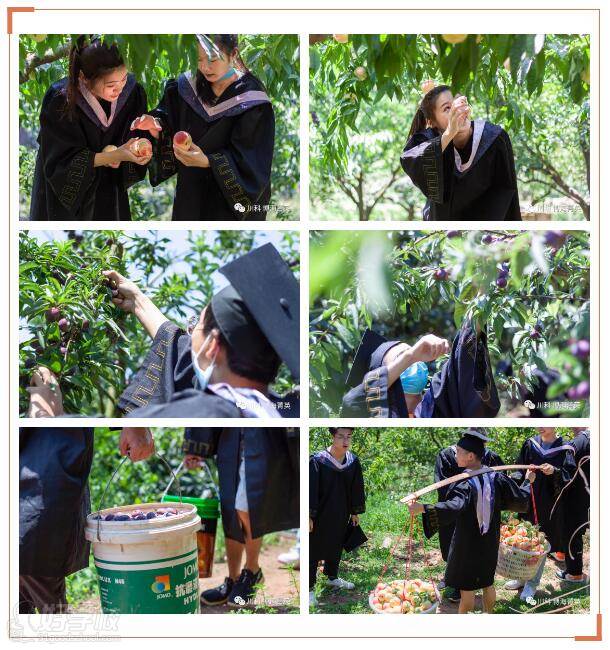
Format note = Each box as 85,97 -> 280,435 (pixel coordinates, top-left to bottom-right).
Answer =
19,34 -> 299,220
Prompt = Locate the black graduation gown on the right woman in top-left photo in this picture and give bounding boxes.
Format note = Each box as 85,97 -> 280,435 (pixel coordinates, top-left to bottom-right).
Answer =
150,72 -> 275,221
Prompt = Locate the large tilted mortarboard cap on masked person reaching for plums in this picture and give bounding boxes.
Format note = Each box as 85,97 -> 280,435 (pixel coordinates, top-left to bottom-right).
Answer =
211,244 -> 300,380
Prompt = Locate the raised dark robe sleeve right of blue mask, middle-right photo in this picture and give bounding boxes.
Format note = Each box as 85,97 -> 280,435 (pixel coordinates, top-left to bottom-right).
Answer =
422,323 -> 500,418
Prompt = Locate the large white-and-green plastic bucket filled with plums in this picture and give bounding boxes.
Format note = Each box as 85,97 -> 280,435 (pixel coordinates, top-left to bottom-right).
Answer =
85,503 -> 201,614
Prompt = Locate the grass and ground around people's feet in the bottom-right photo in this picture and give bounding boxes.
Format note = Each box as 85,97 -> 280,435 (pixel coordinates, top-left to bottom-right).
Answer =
310,492 -> 589,614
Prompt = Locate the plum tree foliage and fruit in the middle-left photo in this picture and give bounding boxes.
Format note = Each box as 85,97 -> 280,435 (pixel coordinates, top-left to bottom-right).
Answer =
19,230 -> 299,417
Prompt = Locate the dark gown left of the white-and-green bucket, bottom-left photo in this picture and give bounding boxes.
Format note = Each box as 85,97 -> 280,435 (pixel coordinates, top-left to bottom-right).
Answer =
19,427 -> 93,578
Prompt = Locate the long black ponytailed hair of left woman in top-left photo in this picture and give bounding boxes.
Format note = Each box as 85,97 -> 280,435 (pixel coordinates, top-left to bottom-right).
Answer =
66,34 -> 125,117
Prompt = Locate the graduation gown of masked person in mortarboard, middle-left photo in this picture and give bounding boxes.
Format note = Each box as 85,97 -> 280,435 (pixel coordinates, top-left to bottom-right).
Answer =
117,321 -> 299,418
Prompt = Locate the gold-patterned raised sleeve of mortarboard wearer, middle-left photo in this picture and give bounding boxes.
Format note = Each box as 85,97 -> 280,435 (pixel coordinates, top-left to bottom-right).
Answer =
118,321 -> 194,413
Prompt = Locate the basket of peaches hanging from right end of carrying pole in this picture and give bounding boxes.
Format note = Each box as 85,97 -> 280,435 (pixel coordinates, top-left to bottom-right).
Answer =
496,518 -> 551,582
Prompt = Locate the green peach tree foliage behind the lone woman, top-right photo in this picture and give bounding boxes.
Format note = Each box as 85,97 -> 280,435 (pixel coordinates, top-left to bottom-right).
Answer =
310,34 -> 590,220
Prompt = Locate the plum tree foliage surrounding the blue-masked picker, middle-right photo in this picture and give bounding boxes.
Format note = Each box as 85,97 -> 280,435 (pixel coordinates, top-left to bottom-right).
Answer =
309,231 -> 589,416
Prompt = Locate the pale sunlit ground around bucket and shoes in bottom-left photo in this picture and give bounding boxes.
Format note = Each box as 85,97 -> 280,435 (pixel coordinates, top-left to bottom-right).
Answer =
68,533 -> 299,614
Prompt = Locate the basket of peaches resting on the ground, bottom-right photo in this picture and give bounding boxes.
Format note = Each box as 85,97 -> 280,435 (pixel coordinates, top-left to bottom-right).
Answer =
369,580 -> 440,614
